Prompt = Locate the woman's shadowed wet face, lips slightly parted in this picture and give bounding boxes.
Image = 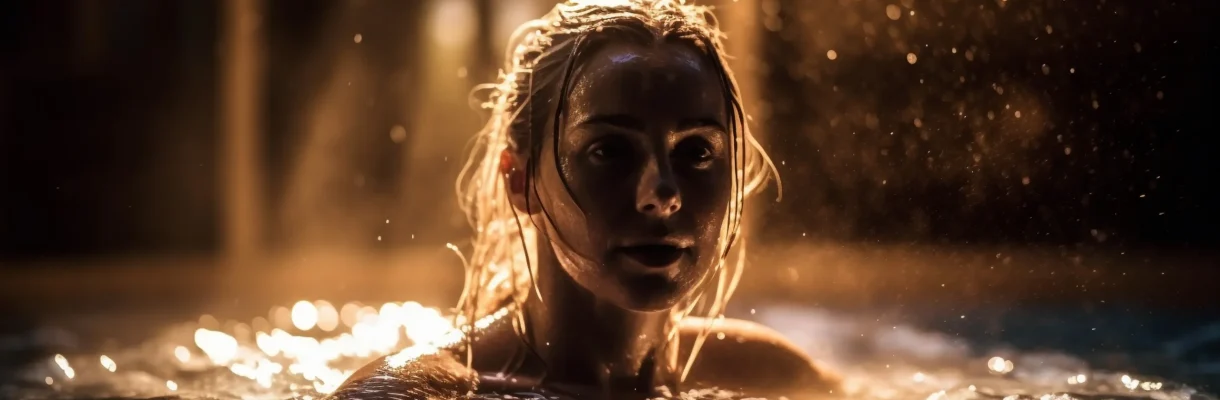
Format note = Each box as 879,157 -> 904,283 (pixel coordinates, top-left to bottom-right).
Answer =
534,43 -> 732,311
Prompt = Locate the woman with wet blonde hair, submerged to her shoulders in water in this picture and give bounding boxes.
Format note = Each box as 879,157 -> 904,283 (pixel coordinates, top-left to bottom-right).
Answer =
334,0 -> 831,399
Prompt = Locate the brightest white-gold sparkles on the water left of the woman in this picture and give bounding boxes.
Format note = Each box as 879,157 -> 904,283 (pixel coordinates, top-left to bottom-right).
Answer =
159,300 -> 456,394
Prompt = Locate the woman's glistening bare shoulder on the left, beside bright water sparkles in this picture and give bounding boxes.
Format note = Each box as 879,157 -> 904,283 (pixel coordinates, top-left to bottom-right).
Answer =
328,349 -> 477,400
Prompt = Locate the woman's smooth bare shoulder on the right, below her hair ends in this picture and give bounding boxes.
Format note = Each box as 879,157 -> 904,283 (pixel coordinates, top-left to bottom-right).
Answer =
680,318 -> 839,398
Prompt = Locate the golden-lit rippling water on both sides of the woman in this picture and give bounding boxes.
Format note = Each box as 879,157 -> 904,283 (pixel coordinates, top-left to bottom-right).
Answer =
7,300 -> 1214,400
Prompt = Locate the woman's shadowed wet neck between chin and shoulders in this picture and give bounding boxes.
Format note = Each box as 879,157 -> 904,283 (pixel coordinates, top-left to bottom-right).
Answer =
523,239 -> 675,393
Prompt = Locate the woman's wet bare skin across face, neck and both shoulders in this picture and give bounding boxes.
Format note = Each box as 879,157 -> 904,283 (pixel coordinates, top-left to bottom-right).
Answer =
334,41 -> 833,399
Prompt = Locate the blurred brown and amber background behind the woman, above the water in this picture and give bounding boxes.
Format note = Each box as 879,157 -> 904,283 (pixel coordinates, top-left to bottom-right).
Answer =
0,0 -> 1220,392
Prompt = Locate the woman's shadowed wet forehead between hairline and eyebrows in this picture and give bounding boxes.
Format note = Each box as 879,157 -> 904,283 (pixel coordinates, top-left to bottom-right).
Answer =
567,43 -> 725,122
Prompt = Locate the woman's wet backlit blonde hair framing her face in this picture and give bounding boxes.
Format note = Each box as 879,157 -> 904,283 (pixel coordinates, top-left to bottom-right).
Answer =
456,0 -> 775,377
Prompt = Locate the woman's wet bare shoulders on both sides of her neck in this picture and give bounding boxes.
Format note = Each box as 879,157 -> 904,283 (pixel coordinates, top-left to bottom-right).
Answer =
333,307 -> 841,400
